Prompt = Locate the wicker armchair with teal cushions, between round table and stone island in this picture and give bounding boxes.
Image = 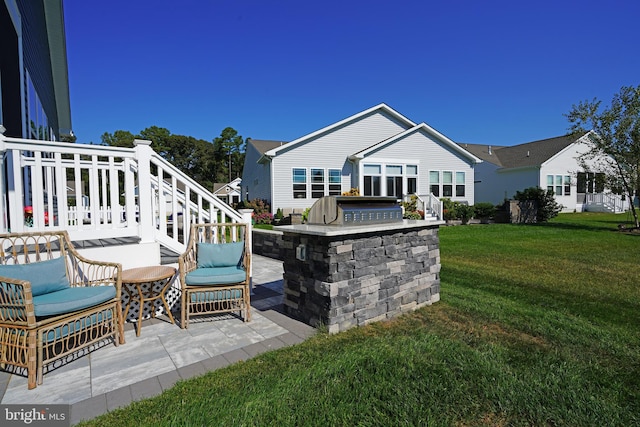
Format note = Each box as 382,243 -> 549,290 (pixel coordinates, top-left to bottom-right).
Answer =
178,223 -> 251,328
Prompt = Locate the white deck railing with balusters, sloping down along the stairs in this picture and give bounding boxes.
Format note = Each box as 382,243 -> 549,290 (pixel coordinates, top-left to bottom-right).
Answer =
0,133 -> 251,252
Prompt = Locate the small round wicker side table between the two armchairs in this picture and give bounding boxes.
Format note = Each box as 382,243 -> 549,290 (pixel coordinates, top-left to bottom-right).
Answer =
122,265 -> 177,337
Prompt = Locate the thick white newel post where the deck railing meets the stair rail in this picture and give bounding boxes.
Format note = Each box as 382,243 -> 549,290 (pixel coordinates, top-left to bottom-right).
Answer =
133,139 -> 155,243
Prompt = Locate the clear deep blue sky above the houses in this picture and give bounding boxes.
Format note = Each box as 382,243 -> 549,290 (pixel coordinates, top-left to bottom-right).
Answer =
64,0 -> 640,145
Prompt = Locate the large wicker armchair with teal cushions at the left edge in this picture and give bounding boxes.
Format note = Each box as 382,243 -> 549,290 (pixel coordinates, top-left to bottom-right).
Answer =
0,231 -> 124,389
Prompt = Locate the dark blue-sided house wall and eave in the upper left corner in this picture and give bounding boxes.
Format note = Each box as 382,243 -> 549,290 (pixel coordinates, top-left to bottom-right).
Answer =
0,0 -> 73,141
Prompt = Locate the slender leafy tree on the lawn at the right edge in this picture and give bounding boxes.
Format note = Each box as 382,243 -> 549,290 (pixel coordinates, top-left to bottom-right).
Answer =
566,86 -> 640,227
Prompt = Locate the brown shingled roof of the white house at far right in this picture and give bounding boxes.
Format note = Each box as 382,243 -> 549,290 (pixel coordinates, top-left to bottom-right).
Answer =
460,135 -> 579,169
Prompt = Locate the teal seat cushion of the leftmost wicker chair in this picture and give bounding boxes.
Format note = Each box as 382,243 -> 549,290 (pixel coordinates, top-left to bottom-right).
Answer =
33,286 -> 116,317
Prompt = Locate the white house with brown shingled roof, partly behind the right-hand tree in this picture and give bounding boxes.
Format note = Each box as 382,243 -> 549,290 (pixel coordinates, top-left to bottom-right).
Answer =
460,134 -> 621,212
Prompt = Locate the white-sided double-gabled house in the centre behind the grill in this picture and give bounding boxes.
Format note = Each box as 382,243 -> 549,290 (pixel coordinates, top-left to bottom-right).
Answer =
242,104 -> 481,214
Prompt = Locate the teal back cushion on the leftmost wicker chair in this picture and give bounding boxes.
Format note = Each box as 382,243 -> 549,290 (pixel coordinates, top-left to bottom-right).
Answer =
0,257 -> 69,297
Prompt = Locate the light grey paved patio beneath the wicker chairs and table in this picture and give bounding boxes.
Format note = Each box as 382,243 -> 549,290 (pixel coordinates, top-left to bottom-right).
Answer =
0,255 -> 315,424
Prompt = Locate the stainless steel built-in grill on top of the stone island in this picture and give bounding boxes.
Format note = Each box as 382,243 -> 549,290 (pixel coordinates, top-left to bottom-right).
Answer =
307,196 -> 402,225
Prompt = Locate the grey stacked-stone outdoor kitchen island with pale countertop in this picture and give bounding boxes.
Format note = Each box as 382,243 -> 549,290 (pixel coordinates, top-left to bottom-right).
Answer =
278,198 -> 443,333
